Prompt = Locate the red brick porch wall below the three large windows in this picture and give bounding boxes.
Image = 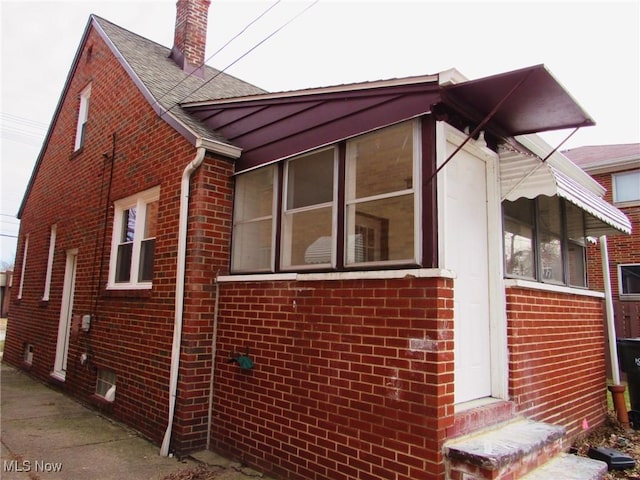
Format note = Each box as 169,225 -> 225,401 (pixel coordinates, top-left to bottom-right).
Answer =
212,278 -> 453,480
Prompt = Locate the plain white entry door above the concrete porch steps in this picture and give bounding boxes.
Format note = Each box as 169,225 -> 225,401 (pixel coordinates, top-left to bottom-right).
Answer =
442,143 -> 491,404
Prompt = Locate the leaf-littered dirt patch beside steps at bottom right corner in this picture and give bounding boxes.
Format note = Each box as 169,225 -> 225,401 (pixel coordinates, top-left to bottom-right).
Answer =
572,414 -> 640,480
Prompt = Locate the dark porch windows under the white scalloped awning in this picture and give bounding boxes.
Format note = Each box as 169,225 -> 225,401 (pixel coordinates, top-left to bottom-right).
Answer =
502,196 -> 587,287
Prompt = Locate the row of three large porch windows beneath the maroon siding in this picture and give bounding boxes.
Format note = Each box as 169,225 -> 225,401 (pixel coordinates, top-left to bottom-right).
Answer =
231,120 -> 421,273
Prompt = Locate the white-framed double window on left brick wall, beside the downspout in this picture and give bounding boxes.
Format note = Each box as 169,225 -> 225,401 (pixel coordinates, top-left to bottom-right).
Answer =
109,188 -> 160,289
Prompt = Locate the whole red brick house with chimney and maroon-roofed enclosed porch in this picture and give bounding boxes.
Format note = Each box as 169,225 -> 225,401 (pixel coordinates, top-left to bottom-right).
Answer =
4,0 -> 630,480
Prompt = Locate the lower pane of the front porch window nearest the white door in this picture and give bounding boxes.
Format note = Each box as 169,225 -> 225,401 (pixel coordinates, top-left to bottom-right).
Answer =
345,194 -> 415,264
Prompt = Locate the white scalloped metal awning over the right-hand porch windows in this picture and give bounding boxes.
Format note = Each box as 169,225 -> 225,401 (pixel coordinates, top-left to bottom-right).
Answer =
499,138 -> 631,237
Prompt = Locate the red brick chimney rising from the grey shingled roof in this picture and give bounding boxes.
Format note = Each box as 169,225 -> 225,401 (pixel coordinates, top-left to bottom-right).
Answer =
170,0 -> 211,78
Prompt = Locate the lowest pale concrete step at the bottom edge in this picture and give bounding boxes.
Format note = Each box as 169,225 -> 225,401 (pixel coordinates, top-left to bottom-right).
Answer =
522,453 -> 607,480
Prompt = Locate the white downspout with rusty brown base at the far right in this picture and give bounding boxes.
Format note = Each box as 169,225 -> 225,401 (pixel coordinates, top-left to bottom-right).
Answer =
600,235 -> 629,429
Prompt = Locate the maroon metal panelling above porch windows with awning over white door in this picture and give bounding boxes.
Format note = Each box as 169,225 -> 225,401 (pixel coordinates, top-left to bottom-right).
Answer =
182,65 -> 595,172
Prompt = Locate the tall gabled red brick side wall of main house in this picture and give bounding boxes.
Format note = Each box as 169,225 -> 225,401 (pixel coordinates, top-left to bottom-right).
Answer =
4,24 -> 225,452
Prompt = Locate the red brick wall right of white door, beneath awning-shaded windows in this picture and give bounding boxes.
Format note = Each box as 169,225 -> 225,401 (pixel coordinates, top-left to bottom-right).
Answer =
507,288 -> 606,435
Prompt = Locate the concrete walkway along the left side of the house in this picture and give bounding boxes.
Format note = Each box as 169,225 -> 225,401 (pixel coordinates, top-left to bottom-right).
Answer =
0,364 -> 264,480
